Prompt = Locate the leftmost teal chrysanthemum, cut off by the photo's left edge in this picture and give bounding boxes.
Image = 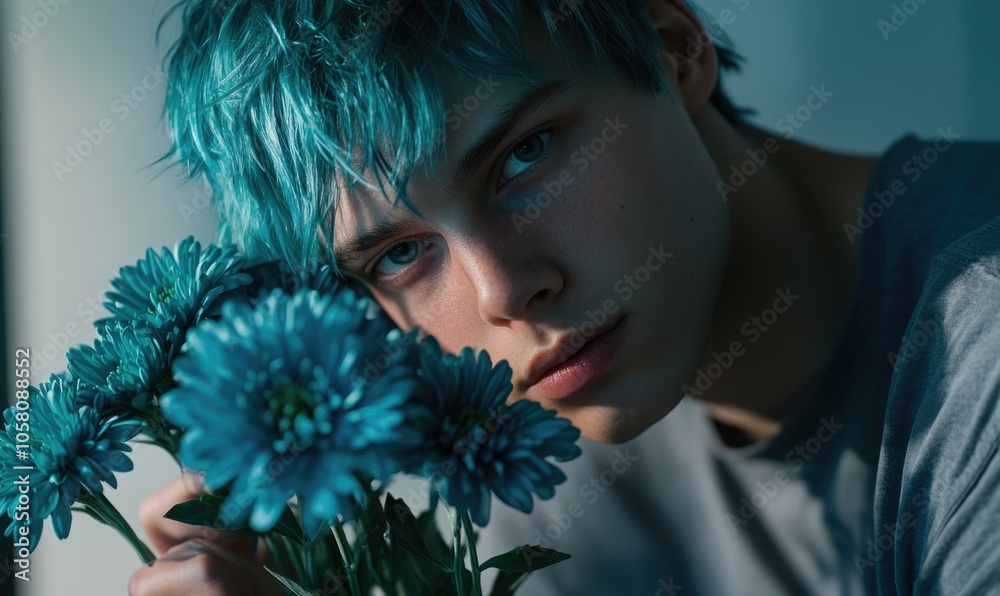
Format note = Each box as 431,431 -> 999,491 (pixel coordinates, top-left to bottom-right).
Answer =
0,375 -> 142,551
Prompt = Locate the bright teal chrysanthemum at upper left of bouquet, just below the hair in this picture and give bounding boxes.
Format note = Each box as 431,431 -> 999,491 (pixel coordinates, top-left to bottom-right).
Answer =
94,236 -> 252,353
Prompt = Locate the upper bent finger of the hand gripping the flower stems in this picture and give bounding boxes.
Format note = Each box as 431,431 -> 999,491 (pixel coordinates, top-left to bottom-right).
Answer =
139,472 -> 253,557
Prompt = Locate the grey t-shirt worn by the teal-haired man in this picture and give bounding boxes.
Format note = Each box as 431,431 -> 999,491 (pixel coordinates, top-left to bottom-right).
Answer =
479,129 -> 1000,596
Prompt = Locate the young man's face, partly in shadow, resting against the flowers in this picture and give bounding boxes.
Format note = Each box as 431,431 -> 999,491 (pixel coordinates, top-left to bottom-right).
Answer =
334,15 -> 729,442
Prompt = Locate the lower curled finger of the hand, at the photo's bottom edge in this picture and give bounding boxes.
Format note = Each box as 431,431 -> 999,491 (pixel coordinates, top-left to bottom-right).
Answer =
128,539 -> 283,596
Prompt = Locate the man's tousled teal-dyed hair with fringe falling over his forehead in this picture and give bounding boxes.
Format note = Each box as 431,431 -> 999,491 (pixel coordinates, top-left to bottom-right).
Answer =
158,0 -> 741,274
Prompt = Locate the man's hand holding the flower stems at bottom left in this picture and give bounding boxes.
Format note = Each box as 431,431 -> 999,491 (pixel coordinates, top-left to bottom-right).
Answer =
128,473 -> 284,596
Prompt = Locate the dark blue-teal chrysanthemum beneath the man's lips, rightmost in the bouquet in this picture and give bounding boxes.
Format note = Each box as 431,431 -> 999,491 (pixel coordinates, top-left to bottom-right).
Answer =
407,337 -> 580,526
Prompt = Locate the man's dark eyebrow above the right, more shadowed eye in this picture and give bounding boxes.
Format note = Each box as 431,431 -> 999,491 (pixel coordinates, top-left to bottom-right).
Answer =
446,79 -> 573,194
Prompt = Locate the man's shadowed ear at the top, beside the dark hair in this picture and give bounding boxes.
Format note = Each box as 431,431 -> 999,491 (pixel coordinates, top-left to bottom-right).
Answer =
646,0 -> 719,112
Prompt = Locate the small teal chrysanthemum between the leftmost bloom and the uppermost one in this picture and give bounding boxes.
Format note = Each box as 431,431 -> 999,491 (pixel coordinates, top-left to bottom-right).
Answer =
66,323 -> 167,415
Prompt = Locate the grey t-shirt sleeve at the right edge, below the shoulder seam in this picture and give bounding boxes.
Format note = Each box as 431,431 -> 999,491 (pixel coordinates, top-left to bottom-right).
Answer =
872,218 -> 1000,595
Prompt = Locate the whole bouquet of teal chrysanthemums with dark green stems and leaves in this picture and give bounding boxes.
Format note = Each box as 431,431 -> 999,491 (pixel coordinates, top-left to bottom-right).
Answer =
0,237 -> 580,596
